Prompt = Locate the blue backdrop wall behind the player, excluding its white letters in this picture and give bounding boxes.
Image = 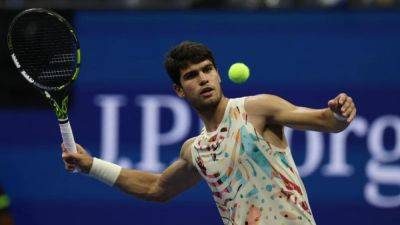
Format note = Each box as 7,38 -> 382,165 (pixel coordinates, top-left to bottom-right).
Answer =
0,11 -> 400,225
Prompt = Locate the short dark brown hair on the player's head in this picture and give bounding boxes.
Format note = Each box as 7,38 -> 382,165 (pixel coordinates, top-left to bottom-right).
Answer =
164,41 -> 216,85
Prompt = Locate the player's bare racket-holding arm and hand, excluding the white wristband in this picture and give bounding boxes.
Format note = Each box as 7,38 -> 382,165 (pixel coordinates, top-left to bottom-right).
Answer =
63,139 -> 201,202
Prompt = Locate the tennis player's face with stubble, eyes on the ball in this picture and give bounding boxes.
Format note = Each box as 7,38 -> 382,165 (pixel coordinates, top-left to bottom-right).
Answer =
174,60 -> 222,110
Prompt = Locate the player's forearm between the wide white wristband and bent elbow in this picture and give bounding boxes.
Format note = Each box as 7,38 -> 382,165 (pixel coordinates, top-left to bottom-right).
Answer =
114,169 -> 163,202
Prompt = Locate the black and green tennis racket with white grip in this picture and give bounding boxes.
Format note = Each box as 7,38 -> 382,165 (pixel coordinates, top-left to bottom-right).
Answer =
7,8 -> 81,152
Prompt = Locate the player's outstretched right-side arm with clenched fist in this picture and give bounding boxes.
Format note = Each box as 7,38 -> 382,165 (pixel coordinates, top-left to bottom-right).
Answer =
246,93 -> 356,132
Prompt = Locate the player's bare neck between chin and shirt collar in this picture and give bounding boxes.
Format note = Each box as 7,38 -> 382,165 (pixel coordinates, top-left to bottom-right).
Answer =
198,96 -> 228,132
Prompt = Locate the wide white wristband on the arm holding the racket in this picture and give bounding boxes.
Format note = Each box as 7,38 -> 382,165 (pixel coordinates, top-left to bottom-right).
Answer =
89,157 -> 122,186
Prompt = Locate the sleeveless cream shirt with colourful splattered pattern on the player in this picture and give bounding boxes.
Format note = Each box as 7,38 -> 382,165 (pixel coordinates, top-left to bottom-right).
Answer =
191,98 -> 315,225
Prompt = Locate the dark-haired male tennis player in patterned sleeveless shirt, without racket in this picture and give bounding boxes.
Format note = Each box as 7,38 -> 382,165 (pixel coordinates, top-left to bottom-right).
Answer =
63,42 -> 356,225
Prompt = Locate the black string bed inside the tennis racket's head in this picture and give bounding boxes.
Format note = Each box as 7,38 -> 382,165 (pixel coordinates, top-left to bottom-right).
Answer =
12,13 -> 77,87
